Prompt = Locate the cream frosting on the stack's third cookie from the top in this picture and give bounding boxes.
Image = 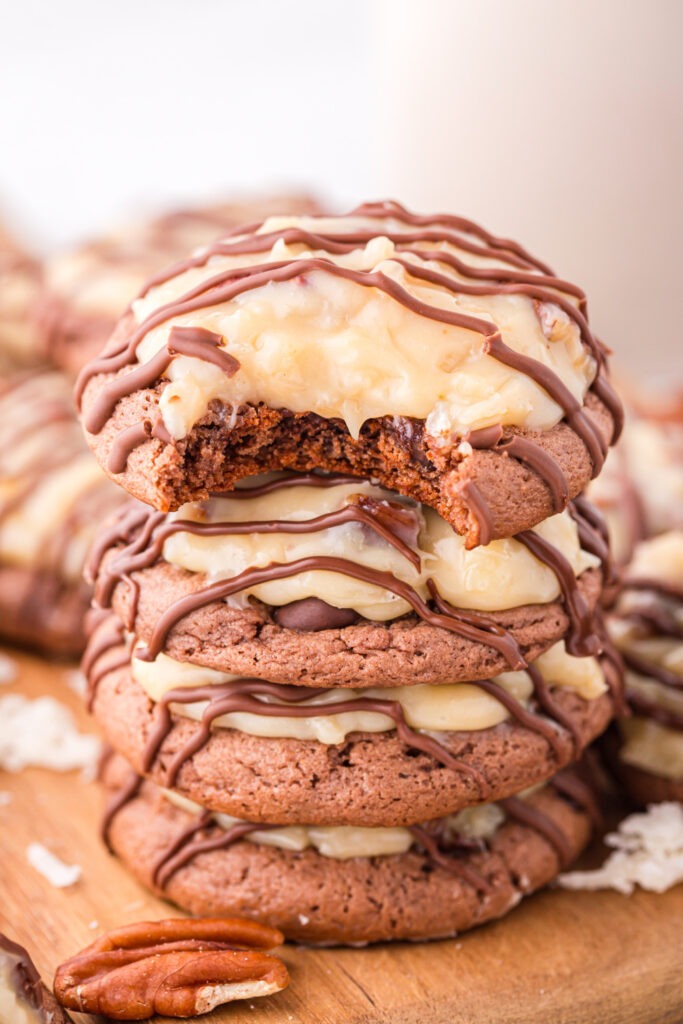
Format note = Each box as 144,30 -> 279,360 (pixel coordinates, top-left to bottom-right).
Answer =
132,643 -> 606,743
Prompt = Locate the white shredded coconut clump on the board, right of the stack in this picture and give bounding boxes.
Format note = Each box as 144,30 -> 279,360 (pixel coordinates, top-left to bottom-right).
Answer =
558,803 -> 683,895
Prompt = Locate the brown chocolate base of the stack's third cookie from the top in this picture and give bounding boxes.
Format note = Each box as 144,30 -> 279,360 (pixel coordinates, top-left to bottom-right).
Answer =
90,648 -> 620,825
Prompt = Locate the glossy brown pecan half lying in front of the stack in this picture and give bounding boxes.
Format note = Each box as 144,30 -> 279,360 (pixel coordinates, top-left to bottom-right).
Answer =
54,919 -> 289,1020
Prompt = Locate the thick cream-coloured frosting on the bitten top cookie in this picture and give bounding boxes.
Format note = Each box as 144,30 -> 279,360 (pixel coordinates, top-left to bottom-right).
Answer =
133,211 -> 596,442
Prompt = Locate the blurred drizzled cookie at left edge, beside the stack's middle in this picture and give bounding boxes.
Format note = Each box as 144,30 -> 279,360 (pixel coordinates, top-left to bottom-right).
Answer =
0,371 -> 122,656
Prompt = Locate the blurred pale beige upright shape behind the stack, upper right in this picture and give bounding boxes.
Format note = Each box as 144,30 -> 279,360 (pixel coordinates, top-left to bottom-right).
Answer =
376,0 -> 683,384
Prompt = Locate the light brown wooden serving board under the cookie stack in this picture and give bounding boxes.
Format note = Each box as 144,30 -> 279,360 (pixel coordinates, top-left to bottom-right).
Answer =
0,652 -> 683,1024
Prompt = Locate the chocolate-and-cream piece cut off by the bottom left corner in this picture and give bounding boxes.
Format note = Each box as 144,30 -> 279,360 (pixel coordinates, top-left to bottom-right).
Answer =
0,934 -> 73,1024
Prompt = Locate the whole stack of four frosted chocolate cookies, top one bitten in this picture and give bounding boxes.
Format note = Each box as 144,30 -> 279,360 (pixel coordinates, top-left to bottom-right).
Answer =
77,203 -> 621,943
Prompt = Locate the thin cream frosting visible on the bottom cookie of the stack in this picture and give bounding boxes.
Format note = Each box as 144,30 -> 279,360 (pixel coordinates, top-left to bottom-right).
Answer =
163,790 -> 505,860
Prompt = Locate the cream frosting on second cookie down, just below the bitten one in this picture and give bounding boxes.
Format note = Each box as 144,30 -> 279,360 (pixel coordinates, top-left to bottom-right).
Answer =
164,481 -> 599,622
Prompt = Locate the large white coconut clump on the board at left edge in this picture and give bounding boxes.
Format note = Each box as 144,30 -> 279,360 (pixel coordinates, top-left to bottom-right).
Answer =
0,693 -> 99,775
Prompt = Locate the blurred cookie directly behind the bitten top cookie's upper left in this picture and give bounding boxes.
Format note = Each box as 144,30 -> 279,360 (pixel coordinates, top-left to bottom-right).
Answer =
37,196 -> 318,375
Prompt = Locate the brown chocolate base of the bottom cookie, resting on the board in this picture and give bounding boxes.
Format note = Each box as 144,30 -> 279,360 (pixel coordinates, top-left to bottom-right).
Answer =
101,759 -> 593,944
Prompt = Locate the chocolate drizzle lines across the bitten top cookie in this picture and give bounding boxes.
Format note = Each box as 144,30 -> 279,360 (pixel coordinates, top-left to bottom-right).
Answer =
76,202 -> 623,491
